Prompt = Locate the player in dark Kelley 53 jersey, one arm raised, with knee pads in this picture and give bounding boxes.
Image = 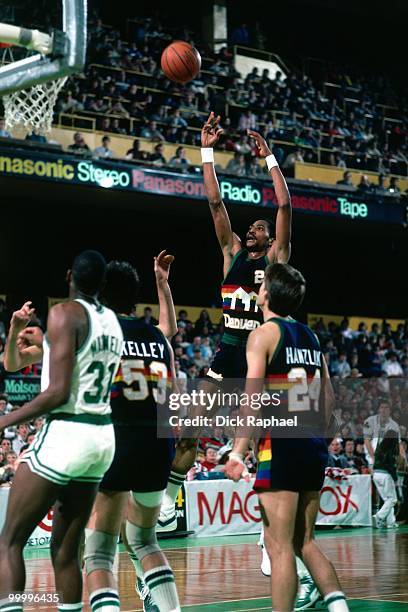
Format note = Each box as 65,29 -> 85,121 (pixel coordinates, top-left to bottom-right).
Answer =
84,251 -> 180,612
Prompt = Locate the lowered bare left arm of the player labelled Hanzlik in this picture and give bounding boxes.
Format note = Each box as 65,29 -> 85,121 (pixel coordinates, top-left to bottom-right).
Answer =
225,324 -> 281,481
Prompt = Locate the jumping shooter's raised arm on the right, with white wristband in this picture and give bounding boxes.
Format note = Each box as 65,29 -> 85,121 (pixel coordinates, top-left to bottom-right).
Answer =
248,130 -> 292,263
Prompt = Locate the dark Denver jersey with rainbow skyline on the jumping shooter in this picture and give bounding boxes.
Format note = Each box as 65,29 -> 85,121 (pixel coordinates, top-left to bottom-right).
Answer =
221,249 -> 269,346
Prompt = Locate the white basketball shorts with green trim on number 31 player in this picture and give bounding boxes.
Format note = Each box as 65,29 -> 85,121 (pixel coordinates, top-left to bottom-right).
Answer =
20,419 -> 115,485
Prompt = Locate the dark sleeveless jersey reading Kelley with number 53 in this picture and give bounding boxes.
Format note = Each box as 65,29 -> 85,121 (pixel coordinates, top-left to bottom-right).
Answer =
111,316 -> 171,427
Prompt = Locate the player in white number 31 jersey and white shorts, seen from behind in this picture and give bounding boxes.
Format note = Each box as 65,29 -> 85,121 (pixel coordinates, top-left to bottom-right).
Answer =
0,251 -> 123,612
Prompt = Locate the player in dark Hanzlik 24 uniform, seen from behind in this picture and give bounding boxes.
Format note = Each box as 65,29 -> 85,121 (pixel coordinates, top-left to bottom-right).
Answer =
226,264 -> 348,612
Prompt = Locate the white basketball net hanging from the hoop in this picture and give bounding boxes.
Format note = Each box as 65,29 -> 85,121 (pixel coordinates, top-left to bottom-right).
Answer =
0,43 -> 68,135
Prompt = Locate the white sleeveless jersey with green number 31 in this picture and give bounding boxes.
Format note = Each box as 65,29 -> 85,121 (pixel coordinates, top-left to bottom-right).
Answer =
41,299 -> 123,415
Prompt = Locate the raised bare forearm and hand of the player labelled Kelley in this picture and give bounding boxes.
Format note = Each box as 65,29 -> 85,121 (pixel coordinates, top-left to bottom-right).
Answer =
154,251 -> 177,338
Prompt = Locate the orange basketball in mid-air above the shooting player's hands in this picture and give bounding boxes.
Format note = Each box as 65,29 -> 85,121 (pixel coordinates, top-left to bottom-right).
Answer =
161,40 -> 201,83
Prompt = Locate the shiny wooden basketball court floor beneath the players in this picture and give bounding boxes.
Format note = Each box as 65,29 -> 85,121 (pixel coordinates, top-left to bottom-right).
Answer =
25,526 -> 408,612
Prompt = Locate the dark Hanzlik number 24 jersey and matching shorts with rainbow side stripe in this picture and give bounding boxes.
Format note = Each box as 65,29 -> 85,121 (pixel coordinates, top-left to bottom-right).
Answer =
254,317 -> 327,491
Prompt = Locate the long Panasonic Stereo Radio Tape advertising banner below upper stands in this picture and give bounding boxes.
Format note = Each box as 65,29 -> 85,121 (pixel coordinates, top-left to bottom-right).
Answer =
0,148 -> 406,225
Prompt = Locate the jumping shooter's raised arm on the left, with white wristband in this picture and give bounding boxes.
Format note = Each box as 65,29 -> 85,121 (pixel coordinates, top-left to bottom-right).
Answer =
201,113 -> 242,272
